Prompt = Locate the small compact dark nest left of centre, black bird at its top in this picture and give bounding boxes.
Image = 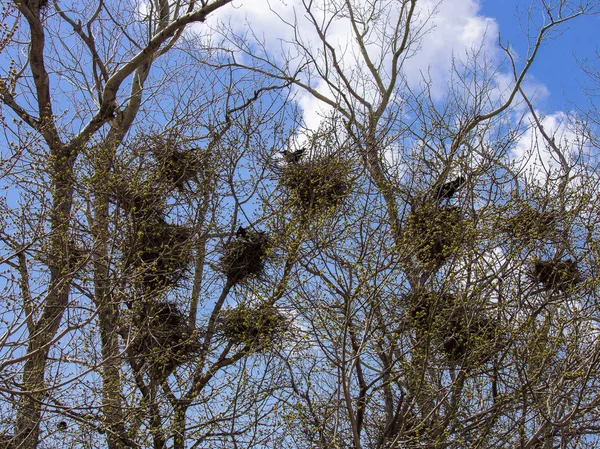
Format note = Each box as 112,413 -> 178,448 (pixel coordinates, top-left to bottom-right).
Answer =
220,231 -> 270,284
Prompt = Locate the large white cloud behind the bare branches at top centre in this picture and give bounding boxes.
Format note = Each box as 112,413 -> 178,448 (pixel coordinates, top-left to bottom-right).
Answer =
208,0 -> 506,127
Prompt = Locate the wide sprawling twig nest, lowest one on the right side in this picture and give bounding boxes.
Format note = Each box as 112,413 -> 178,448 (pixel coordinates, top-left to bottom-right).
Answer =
408,292 -> 501,364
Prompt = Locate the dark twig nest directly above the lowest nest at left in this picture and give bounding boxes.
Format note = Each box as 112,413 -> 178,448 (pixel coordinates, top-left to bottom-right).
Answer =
125,220 -> 192,291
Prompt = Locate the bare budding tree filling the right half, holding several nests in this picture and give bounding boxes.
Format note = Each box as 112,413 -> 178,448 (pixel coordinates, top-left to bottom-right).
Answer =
212,1 -> 599,448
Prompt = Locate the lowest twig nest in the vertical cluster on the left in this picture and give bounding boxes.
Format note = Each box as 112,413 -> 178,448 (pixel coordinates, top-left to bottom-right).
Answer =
131,301 -> 201,377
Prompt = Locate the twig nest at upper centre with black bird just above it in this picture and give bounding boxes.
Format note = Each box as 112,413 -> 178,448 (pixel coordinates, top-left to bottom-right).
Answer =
280,155 -> 350,214
